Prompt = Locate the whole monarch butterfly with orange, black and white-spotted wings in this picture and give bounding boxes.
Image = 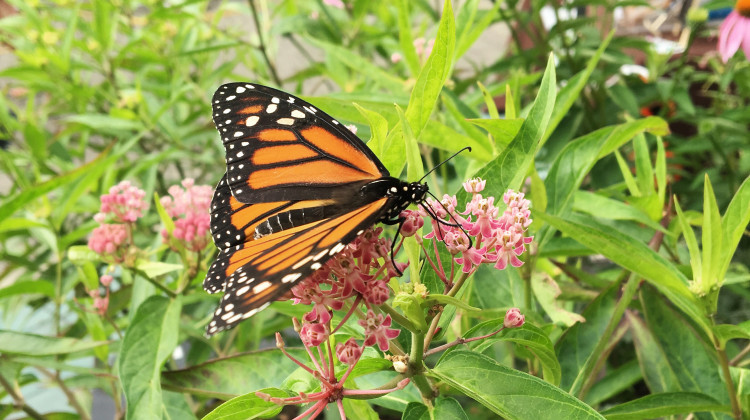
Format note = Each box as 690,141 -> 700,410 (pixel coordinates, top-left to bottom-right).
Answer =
203,83 -> 428,336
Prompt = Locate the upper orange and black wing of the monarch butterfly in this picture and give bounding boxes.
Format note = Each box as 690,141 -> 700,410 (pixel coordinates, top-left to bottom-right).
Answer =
212,83 -> 389,203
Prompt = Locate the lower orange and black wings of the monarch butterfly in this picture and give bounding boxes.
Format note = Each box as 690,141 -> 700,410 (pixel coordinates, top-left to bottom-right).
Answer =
204,175 -> 391,336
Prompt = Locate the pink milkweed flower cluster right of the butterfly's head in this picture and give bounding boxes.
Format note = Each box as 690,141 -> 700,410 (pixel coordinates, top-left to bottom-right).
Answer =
418,178 -> 534,284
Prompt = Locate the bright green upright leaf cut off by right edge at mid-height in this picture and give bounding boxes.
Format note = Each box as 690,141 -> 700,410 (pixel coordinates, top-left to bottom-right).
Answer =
718,177 -> 750,279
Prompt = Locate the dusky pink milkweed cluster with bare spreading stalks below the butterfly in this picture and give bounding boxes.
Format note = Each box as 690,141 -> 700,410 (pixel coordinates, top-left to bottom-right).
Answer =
268,227 -> 409,419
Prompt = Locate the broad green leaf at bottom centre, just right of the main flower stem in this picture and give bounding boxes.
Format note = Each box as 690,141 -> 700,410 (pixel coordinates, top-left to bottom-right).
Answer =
430,350 -> 603,420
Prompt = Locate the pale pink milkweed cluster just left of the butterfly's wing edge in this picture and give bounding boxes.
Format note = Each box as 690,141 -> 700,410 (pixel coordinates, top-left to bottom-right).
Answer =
160,178 -> 213,252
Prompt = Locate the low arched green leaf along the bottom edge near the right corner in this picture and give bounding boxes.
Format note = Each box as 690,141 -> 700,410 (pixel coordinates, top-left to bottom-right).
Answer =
602,392 -> 732,420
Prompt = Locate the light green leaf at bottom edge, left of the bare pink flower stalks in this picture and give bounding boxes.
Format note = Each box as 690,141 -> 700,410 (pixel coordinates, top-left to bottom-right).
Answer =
203,388 -> 289,420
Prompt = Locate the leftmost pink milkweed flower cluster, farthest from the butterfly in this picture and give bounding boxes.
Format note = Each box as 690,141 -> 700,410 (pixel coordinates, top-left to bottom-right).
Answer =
88,181 -> 148,263
